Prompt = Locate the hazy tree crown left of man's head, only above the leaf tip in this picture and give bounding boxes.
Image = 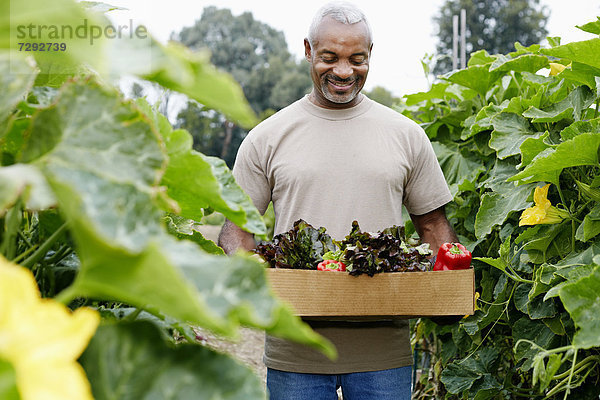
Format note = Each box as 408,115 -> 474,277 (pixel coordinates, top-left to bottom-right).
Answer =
174,6 -> 312,113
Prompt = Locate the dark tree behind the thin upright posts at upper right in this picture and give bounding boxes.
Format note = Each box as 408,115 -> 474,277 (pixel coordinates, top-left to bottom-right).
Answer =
433,0 -> 549,74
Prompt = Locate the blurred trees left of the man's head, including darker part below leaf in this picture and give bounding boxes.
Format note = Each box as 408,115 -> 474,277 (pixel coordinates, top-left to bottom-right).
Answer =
172,6 -> 312,166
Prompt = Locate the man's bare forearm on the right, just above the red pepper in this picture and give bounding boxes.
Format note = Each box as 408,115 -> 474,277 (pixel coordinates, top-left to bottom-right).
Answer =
410,206 -> 458,256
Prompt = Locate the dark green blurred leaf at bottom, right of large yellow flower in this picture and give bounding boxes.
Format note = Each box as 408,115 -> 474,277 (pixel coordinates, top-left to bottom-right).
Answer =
80,322 -> 266,400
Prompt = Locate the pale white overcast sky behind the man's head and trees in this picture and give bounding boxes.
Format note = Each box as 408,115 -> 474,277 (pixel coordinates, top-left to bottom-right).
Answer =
106,0 -> 600,97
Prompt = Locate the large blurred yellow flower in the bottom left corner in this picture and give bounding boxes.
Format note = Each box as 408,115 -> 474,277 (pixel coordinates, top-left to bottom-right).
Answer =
0,256 -> 100,400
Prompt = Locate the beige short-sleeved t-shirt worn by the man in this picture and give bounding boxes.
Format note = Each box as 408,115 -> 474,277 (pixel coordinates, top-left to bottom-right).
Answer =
233,95 -> 452,373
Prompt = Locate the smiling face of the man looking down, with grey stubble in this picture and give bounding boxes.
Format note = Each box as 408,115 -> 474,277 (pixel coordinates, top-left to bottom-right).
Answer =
304,17 -> 372,108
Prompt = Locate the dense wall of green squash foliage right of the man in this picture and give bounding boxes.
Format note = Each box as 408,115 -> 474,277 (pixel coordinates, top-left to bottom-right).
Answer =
398,22 -> 600,400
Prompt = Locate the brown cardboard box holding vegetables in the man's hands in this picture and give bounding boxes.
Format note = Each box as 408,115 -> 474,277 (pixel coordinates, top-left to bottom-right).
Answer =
267,268 -> 475,318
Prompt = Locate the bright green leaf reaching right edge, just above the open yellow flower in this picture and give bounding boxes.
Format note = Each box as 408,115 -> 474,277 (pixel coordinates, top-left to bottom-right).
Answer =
508,133 -> 600,182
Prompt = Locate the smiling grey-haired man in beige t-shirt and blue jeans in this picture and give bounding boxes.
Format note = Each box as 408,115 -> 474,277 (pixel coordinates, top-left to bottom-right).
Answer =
219,3 -> 457,400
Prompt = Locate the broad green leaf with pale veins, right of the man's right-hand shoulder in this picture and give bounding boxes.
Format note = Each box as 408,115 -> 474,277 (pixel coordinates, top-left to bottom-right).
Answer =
490,113 -> 542,159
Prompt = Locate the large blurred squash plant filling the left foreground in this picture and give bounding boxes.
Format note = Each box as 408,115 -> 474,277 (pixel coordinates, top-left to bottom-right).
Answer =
0,0 -> 335,399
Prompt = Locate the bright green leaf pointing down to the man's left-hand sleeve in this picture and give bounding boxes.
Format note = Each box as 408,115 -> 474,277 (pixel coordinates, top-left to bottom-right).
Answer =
161,130 -> 266,235
